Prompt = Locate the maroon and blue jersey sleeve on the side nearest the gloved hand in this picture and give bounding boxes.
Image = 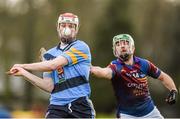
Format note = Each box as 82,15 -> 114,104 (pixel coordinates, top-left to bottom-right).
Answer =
147,61 -> 161,78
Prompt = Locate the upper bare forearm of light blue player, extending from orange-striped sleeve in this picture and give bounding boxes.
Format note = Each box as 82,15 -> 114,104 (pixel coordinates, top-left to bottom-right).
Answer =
10,56 -> 68,73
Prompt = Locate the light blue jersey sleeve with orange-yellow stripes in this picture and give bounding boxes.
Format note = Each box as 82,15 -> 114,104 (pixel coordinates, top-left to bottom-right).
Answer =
61,42 -> 91,65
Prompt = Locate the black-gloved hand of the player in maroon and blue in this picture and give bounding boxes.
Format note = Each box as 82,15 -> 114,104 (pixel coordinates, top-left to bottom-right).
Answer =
165,90 -> 177,105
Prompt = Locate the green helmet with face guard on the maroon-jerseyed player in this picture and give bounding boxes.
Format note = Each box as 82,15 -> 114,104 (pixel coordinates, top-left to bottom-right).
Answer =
113,34 -> 134,61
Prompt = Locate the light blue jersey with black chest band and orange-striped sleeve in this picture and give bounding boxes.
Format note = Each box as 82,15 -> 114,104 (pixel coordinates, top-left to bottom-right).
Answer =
43,40 -> 91,105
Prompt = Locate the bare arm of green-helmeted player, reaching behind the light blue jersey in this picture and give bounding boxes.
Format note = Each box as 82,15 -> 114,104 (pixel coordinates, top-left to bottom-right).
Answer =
90,66 -> 112,79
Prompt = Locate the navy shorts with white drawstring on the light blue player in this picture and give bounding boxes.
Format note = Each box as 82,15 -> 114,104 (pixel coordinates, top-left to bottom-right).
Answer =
46,97 -> 95,118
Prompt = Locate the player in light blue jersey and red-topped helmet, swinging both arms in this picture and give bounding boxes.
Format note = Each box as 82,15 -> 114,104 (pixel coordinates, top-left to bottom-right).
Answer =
10,13 -> 95,118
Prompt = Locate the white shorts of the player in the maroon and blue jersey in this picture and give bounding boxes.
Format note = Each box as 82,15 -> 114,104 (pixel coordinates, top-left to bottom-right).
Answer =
121,106 -> 164,119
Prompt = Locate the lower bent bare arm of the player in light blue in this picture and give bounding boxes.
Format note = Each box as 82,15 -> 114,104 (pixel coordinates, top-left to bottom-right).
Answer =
9,67 -> 54,93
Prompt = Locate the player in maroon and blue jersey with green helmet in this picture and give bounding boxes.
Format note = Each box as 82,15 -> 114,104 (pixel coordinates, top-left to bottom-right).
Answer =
91,34 -> 177,118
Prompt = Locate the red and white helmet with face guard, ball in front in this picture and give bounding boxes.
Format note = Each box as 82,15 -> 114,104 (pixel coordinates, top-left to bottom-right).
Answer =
57,13 -> 79,44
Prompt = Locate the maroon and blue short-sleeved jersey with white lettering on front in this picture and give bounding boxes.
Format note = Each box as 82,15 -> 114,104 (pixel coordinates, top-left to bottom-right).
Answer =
109,57 -> 161,116
